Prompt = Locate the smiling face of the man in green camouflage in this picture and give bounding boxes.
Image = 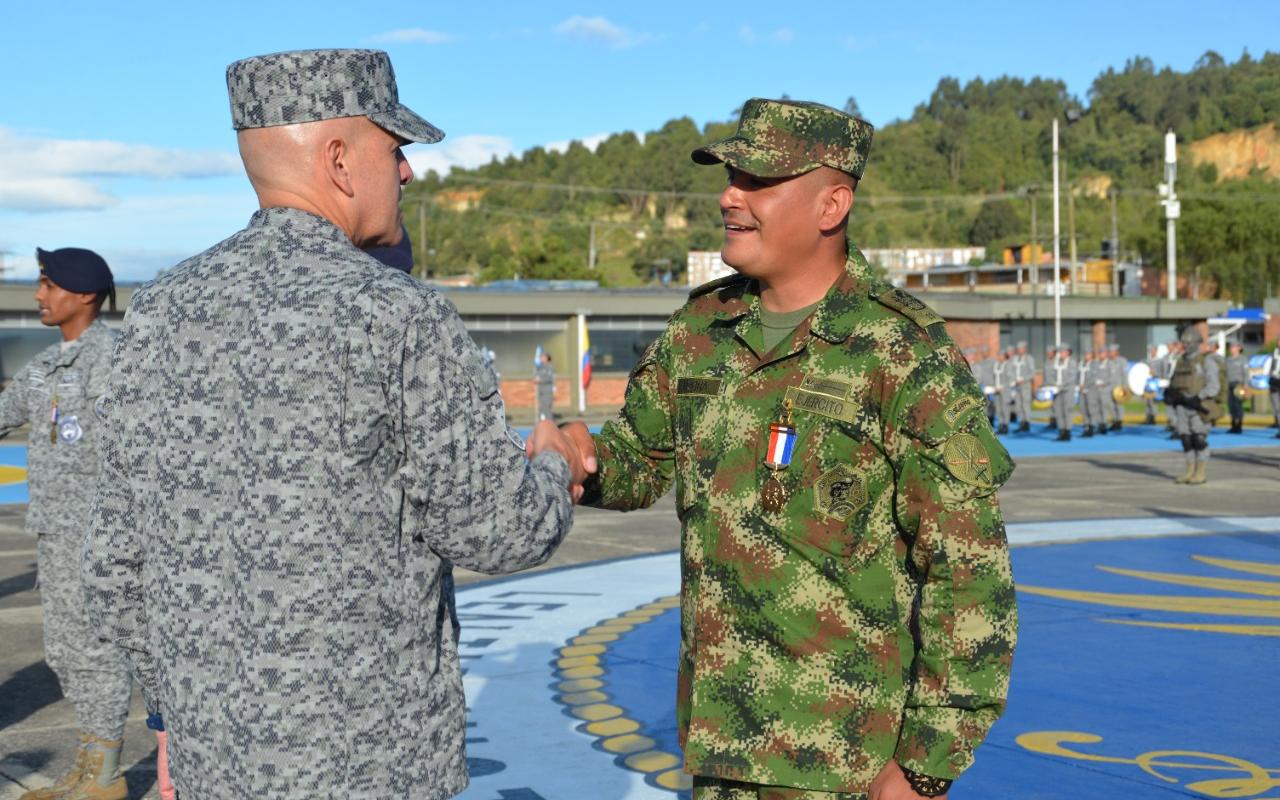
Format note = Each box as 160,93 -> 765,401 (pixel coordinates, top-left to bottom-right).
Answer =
719,164 -> 818,279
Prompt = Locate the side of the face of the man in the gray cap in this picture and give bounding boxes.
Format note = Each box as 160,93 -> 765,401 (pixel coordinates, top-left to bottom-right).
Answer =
351,122 -> 413,247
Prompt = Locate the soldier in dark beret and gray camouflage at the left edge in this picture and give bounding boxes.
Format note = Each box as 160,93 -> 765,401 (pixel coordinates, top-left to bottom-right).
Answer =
0,247 -> 133,800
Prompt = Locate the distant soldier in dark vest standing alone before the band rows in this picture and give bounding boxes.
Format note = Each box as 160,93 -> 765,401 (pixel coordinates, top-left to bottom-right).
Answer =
1165,325 -> 1221,484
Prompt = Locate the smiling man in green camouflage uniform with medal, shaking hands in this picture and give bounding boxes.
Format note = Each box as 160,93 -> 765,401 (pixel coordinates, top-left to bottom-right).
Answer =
567,100 -> 1016,800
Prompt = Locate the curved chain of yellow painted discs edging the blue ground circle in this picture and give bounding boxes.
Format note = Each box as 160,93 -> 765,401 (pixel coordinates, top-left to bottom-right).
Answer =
556,595 -> 692,792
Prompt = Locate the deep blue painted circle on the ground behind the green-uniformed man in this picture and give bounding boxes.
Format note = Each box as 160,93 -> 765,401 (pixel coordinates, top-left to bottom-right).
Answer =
605,532 -> 1280,800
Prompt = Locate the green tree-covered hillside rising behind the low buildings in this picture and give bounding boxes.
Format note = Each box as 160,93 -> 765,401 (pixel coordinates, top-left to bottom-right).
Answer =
403,52 -> 1280,301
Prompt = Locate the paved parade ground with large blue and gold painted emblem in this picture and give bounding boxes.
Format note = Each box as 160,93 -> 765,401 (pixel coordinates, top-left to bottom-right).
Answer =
0,425 -> 1280,800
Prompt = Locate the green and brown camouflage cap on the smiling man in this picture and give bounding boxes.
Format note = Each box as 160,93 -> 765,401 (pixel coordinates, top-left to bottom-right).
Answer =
692,97 -> 874,180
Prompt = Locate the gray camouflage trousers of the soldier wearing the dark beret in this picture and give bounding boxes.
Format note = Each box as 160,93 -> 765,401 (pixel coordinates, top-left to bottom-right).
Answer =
37,534 -> 133,739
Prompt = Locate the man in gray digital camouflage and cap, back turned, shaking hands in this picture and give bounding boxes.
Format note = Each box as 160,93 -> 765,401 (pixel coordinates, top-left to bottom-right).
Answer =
83,50 -> 581,800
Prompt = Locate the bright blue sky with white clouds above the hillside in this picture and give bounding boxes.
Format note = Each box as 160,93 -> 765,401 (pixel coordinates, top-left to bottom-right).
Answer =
0,0 -> 1280,279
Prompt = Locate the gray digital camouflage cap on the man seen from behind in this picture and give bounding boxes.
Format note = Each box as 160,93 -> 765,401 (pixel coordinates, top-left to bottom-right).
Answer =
227,50 -> 444,143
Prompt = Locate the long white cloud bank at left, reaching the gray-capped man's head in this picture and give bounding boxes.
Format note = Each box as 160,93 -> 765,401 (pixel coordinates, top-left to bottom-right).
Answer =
0,127 -> 242,211
